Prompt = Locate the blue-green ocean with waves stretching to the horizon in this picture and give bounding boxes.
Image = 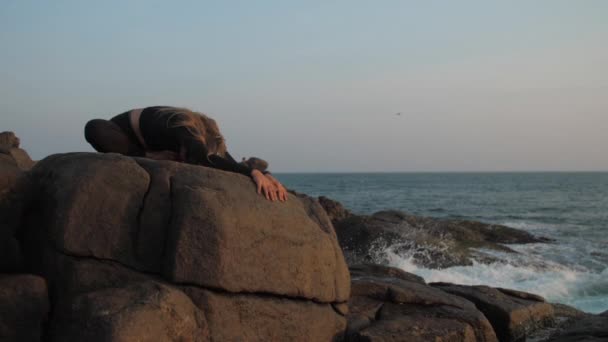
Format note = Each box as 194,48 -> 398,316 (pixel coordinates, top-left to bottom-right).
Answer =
276,172 -> 608,313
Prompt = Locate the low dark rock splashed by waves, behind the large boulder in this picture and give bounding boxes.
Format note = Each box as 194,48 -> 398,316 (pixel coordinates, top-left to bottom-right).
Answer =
319,198 -> 550,268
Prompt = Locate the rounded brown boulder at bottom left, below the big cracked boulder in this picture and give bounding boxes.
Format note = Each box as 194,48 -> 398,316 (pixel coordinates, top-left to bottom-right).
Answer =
50,281 -> 209,342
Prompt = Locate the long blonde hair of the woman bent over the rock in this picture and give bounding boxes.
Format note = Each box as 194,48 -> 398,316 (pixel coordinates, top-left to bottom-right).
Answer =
160,107 -> 226,157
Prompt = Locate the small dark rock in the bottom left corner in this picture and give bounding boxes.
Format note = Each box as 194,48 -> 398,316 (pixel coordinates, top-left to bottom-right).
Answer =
0,275 -> 49,342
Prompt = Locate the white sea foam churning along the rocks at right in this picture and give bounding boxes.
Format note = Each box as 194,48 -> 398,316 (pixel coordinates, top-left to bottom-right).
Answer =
382,240 -> 608,313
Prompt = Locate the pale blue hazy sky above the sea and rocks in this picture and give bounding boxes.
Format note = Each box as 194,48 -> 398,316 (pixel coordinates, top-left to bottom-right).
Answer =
0,0 -> 608,172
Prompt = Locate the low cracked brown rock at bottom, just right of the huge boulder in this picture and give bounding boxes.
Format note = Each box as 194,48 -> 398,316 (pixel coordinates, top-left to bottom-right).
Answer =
346,266 -> 497,342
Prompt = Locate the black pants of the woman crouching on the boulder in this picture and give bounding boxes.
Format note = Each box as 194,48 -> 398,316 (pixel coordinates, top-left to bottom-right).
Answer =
84,112 -> 146,157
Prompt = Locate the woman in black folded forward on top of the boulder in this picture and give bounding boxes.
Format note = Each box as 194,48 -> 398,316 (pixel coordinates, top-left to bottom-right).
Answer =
84,106 -> 287,201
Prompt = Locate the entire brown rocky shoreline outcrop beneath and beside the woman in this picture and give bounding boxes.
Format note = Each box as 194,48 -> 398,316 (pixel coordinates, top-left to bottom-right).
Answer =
0,137 -> 605,342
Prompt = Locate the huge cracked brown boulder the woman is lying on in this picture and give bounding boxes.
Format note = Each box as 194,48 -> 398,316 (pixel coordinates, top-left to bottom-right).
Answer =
20,153 -> 350,341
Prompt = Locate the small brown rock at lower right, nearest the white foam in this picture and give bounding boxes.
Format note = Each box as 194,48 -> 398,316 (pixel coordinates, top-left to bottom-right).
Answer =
431,283 -> 555,341
